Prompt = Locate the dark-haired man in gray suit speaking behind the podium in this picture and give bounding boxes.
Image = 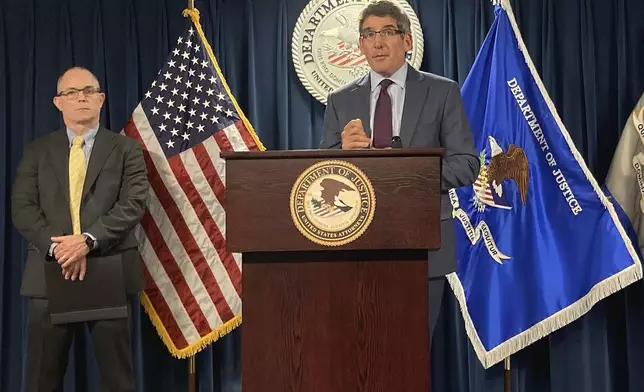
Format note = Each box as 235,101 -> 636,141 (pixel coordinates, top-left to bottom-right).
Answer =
320,1 -> 479,344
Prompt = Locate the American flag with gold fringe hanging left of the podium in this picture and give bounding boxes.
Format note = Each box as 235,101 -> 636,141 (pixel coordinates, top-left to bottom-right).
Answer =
123,19 -> 263,358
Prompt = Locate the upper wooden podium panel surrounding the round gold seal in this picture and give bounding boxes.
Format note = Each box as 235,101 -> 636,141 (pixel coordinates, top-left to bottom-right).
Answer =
226,153 -> 441,252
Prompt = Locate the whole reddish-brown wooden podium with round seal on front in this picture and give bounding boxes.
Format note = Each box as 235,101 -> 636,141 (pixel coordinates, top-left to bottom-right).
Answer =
222,149 -> 443,392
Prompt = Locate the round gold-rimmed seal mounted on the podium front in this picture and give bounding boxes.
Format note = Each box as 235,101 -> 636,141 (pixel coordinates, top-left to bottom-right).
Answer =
290,160 -> 376,246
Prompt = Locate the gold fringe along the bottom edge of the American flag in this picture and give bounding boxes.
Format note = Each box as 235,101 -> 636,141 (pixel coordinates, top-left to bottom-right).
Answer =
139,291 -> 242,359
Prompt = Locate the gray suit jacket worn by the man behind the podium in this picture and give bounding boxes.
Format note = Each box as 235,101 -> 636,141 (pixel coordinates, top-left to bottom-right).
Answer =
320,66 -> 479,277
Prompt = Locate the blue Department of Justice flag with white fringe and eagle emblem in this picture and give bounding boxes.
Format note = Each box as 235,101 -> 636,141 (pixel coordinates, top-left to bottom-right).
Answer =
448,1 -> 642,368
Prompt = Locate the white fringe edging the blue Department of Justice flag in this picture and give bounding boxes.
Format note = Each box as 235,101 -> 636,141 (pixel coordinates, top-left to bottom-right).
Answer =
447,0 -> 642,369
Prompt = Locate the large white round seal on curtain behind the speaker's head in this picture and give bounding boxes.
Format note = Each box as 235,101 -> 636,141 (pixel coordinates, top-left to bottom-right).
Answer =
291,0 -> 424,104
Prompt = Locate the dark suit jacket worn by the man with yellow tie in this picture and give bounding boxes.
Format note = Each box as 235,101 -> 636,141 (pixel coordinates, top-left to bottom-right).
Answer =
11,127 -> 149,298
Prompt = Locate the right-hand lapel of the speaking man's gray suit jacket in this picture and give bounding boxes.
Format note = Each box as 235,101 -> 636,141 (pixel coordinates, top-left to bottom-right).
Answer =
400,65 -> 429,147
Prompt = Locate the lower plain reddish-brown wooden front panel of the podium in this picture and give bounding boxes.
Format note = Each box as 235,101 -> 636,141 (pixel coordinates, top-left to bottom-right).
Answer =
242,250 -> 430,392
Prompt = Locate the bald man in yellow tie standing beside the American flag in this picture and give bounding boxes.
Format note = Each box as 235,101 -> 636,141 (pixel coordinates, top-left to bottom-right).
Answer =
12,67 -> 149,392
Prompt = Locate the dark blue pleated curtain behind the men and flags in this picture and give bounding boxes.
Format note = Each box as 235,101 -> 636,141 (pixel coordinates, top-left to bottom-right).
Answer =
0,0 -> 644,392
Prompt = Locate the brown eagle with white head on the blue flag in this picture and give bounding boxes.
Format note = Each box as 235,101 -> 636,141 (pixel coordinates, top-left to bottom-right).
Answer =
487,136 -> 528,204
